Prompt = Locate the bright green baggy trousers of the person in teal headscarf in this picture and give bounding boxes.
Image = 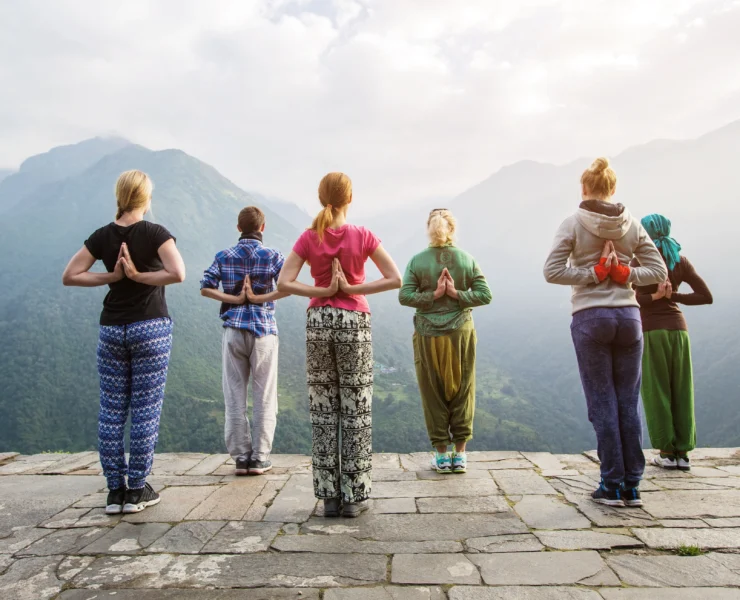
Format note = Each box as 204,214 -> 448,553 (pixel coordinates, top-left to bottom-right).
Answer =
642,329 -> 696,454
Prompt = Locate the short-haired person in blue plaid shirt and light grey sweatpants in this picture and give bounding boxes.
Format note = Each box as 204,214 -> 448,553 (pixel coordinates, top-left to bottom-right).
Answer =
200,206 -> 288,475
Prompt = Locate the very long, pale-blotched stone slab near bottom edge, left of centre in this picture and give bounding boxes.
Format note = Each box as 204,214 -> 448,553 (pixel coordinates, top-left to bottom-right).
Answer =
72,552 -> 388,589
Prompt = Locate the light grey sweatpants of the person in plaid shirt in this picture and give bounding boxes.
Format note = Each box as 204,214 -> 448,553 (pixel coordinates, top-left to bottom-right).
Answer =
223,327 -> 278,460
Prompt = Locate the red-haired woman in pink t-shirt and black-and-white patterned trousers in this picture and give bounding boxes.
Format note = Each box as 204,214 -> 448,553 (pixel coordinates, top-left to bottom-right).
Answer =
278,173 -> 401,517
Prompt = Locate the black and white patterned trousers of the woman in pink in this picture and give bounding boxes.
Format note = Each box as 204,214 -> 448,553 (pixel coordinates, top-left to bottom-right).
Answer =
306,306 -> 373,503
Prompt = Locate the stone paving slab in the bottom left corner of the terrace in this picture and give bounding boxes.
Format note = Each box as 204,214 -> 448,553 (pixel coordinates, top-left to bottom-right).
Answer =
0,556 -> 63,600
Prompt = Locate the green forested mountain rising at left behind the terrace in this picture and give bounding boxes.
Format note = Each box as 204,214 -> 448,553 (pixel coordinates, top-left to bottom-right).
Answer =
0,140 -> 589,452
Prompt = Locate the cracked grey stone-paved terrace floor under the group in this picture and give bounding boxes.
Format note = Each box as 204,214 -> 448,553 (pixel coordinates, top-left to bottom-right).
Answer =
0,448 -> 740,600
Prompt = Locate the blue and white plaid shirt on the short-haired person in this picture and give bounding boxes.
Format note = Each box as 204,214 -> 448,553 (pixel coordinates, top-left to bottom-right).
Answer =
200,239 -> 285,337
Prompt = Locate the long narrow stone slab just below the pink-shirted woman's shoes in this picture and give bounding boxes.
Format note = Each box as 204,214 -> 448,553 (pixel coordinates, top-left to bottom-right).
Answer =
272,534 -> 463,554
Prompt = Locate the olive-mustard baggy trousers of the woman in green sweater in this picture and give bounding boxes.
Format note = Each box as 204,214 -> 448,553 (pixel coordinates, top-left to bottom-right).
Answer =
414,321 -> 477,446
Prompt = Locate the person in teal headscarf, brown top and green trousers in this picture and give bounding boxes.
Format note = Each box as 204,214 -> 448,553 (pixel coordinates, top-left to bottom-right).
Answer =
635,214 -> 713,471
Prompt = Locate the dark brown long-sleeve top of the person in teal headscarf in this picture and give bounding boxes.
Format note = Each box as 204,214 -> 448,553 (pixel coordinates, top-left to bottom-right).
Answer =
633,256 -> 714,331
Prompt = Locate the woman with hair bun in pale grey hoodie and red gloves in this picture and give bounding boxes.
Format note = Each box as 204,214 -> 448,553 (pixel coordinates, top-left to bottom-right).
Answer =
544,158 -> 668,506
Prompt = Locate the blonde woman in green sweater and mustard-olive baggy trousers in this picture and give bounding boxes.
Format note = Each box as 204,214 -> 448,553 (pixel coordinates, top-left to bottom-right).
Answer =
398,208 -> 491,473
